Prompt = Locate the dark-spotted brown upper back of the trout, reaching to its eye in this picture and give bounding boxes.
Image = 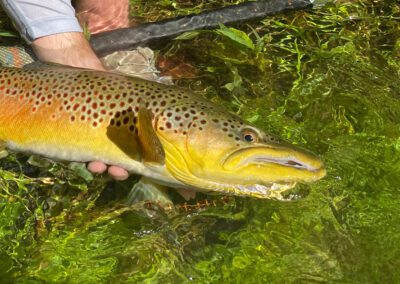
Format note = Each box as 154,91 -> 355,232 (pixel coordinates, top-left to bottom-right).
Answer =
0,67 -> 277,145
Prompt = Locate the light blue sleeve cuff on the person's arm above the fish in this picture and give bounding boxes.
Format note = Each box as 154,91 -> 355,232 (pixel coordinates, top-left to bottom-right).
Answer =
0,0 -> 82,43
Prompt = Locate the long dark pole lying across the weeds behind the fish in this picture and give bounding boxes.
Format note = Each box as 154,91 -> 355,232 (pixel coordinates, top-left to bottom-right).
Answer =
90,0 -> 313,56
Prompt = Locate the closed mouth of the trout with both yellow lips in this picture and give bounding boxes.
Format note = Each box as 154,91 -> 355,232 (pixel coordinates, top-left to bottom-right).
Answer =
223,145 -> 326,185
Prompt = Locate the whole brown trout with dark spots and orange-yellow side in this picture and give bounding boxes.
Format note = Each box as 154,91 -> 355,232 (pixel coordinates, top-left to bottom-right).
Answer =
0,66 -> 326,198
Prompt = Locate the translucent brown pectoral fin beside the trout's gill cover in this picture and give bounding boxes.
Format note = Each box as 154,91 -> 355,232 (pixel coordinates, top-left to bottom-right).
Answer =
138,107 -> 165,164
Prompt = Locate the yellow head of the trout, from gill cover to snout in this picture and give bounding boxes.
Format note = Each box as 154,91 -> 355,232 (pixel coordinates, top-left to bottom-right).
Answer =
155,98 -> 325,198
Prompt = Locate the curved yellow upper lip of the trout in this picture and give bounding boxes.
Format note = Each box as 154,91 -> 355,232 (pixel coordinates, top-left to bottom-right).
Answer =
222,145 -> 325,172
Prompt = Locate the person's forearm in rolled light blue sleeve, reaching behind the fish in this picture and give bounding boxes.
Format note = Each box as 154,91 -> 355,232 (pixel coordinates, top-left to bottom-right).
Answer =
1,0 -> 103,69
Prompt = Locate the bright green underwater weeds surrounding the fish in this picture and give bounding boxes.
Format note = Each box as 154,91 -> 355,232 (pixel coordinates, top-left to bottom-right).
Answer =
0,0 -> 400,283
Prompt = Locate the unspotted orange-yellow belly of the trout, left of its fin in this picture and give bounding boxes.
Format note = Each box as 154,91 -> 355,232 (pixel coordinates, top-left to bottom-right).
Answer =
0,95 -> 139,172
